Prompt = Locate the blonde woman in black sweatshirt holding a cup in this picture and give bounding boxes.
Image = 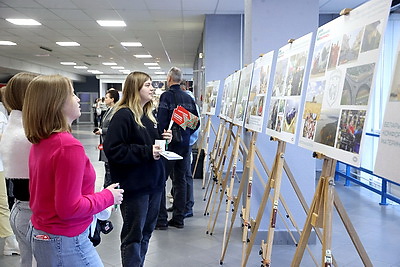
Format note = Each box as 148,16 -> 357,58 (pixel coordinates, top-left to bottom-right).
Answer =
103,72 -> 172,266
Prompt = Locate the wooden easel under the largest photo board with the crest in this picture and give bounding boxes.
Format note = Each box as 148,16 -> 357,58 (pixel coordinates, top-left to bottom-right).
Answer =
291,153 -> 373,267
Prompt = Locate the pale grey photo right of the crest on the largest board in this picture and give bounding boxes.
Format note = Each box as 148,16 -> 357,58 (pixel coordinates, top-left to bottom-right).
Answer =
340,63 -> 375,106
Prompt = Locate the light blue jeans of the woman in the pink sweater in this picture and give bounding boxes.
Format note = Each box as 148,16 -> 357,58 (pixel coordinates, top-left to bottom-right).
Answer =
28,224 -> 103,267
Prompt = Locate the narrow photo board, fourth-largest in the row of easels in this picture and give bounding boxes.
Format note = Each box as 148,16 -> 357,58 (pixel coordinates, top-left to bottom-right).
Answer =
233,63 -> 254,126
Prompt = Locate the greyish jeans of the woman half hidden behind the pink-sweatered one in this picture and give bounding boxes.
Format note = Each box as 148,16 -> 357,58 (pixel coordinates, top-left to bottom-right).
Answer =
10,199 -> 33,267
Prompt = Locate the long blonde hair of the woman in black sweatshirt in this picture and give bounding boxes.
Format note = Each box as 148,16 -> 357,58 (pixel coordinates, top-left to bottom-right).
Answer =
114,71 -> 157,127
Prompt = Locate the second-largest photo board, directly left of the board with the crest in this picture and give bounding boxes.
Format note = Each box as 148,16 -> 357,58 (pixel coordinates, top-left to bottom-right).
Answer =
266,33 -> 312,144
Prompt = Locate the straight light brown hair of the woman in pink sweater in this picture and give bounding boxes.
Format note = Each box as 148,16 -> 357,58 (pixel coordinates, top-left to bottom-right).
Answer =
22,75 -> 72,144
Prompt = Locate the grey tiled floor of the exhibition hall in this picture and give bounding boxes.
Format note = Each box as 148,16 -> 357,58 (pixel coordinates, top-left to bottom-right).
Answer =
0,126 -> 400,267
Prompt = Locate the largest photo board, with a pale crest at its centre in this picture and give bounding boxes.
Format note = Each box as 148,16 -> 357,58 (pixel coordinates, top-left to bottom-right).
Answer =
298,0 -> 391,166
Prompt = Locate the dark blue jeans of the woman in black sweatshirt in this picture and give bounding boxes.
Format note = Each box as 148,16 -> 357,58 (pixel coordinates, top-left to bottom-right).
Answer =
121,192 -> 161,267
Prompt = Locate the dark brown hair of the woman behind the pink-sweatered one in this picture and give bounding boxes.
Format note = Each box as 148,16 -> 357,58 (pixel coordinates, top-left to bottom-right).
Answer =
3,72 -> 38,111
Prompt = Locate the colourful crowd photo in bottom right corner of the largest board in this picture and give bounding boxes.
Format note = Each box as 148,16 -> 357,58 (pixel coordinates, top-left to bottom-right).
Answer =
336,110 -> 366,154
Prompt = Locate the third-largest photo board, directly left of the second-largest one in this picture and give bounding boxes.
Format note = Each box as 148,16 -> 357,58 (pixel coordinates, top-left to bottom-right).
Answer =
245,51 -> 274,133
